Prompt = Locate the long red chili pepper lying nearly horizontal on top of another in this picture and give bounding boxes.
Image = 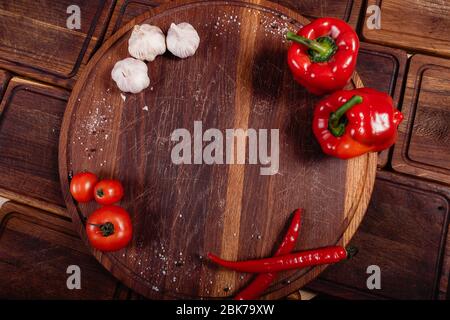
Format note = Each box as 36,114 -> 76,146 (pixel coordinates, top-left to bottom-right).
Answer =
208,246 -> 356,273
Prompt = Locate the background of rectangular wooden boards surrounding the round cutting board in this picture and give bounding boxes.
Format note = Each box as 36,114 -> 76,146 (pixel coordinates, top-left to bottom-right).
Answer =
0,0 -> 450,299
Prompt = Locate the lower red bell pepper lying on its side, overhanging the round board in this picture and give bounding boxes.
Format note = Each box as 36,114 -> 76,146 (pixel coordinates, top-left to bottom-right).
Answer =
313,88 -> 403,159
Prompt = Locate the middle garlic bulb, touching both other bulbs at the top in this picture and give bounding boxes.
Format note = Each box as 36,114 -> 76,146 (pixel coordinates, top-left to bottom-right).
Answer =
128,24 -> 166,61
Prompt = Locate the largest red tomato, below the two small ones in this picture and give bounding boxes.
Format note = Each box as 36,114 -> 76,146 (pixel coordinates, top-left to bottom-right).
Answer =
86,206 -> 133,251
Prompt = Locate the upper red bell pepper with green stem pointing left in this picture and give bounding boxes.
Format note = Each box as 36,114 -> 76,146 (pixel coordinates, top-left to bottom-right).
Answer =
286,18 -> 359,95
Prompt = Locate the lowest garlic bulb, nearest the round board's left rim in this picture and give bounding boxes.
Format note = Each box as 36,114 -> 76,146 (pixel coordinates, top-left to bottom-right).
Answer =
111,58 -> 150,93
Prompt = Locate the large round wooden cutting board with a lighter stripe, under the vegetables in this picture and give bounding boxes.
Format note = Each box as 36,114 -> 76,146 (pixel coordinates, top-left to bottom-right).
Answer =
59,1 -> 377,298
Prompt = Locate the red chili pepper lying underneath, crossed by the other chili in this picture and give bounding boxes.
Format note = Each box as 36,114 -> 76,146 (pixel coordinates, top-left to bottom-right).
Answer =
234,209 -> 303,300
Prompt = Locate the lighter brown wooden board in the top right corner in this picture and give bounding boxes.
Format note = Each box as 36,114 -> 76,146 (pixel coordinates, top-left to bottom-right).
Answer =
362,0 -> 450,57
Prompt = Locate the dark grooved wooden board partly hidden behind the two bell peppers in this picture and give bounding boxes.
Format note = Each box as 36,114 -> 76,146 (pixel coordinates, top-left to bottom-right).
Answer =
357,42 -> 408,168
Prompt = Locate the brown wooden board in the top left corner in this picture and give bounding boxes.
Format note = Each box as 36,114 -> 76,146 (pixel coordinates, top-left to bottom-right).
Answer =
0,0 -> 114,87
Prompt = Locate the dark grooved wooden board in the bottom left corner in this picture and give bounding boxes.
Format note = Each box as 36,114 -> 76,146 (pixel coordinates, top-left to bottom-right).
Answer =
0,202 -> 131,299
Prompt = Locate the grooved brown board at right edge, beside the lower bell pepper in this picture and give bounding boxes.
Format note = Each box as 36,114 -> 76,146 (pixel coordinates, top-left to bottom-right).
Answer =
392,55 -> 450,184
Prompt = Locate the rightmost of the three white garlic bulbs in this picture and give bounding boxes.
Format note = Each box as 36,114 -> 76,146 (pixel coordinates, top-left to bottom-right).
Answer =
166,22 -> 200,58
